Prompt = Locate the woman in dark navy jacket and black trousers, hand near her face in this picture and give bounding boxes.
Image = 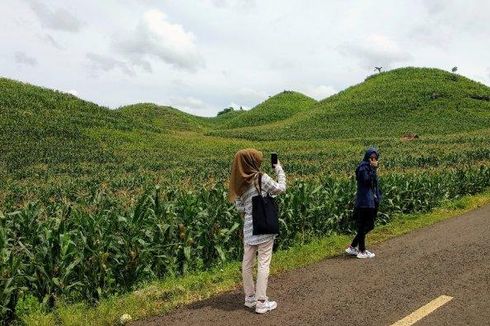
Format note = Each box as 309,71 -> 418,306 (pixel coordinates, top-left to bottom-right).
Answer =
345,147 -> 381,258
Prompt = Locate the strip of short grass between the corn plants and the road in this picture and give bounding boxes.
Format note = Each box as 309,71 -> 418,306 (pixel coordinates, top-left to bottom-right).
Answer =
22,191 -> 490,325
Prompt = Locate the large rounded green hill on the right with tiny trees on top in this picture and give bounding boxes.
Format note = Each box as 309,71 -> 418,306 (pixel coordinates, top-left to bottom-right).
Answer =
212,68 -> 490,140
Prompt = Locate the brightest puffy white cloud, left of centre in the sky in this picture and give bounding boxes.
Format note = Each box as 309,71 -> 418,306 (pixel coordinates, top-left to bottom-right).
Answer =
114,10 -> 204,72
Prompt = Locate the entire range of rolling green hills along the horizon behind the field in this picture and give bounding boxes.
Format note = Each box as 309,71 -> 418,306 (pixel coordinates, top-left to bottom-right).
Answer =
0,68 -> 490,177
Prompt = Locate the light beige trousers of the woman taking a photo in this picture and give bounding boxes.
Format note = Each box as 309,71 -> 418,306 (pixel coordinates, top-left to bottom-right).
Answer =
242,239 -> 274,300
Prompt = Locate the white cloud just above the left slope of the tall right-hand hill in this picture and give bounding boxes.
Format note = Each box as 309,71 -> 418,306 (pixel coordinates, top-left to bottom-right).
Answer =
340,34 -> 412,67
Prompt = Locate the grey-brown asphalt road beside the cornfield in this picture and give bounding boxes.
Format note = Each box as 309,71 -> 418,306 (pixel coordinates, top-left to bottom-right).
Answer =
134,205 -> 490,326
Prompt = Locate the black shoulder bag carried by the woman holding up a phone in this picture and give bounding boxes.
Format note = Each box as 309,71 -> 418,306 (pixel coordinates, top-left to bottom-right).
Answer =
252,173 -> 279,235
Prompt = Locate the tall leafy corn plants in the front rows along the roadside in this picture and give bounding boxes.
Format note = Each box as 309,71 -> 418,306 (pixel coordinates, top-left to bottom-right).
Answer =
0,166 -> 490,319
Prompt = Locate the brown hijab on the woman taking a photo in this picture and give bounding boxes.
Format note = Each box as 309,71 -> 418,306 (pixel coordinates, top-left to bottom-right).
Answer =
228,148 -> 264,202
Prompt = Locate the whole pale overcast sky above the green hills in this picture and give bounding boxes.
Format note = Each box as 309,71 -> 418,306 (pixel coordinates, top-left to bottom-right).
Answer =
0,0 -> 490,116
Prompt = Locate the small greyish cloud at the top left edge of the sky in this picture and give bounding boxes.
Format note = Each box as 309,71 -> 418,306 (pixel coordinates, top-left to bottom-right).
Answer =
26,0 -> 82,32
